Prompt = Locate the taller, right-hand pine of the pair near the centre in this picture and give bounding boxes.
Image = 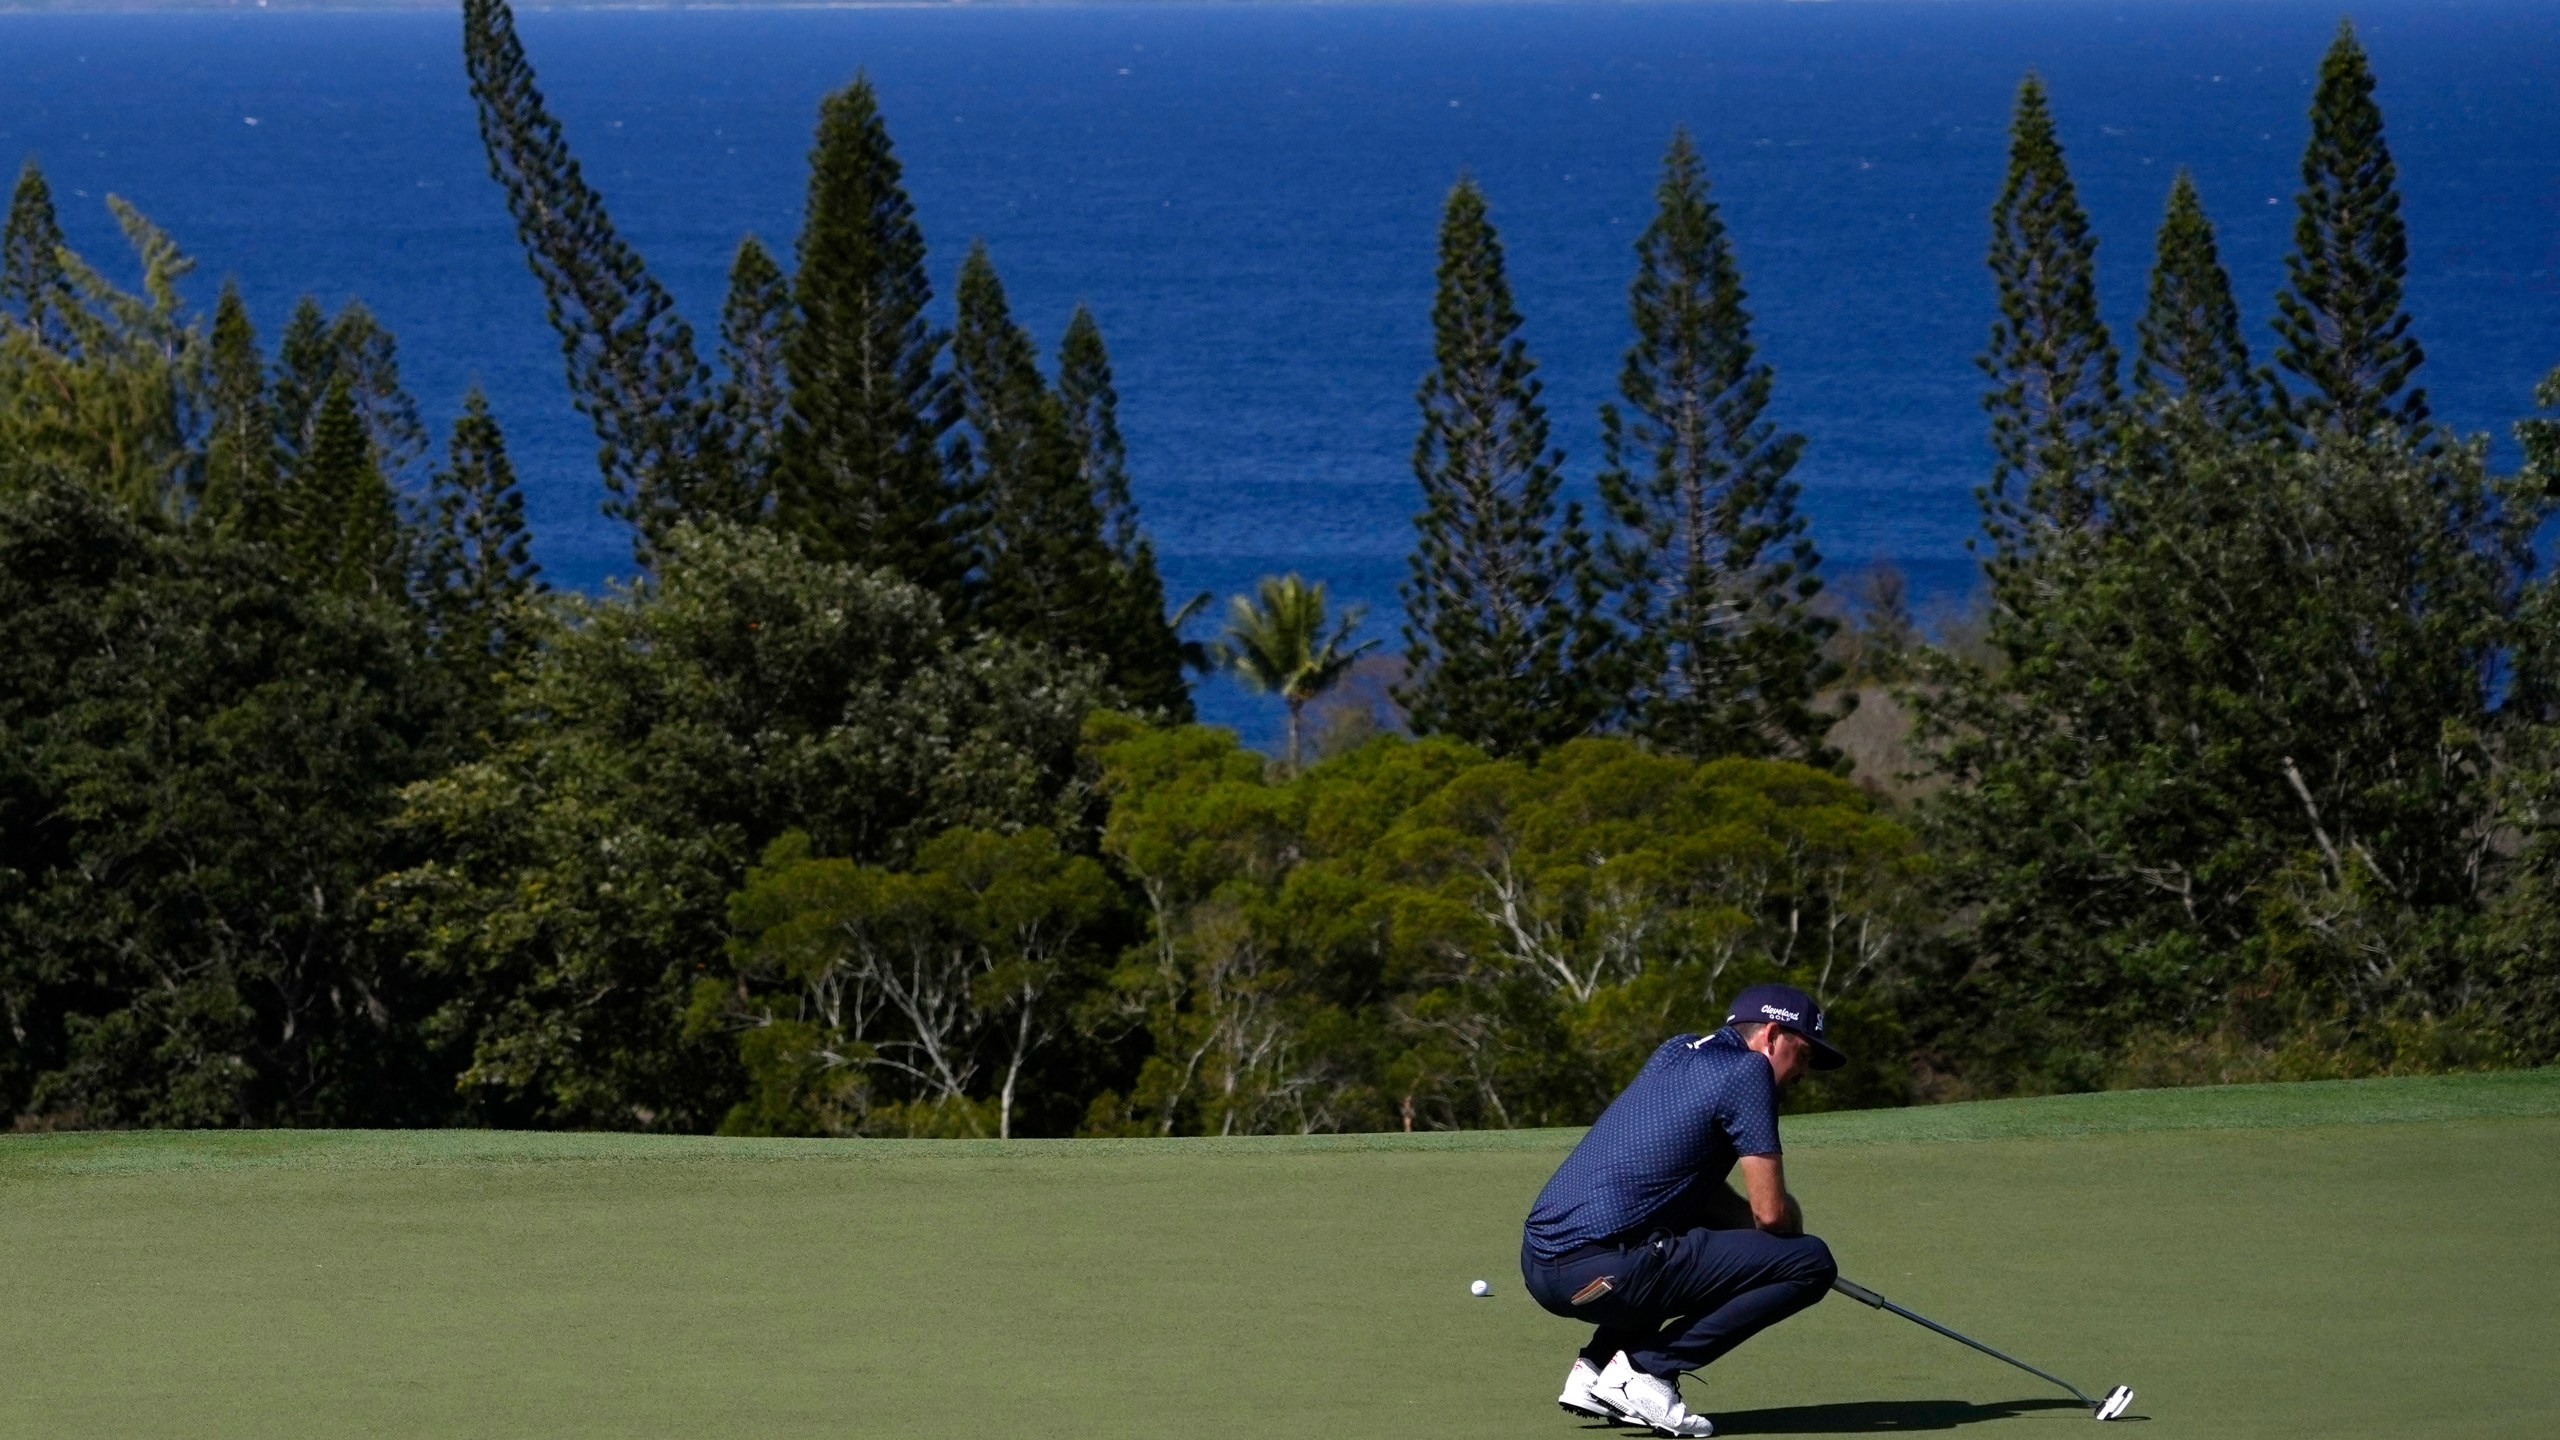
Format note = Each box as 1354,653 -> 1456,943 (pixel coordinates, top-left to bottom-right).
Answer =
1600,131 -> 1841,764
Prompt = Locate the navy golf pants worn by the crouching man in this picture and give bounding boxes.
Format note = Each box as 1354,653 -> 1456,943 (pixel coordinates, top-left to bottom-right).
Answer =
1521,1230 -> 1841,1379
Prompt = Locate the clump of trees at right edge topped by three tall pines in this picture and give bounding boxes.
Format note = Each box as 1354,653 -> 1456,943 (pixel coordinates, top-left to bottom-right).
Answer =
1923,28 -> 2552,1086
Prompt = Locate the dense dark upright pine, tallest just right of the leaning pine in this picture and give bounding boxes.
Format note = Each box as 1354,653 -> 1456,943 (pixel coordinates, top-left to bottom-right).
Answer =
781,77 -> 970,604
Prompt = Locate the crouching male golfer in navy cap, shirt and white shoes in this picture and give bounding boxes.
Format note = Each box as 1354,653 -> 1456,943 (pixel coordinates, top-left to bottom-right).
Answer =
1521,984 -> 1846,1435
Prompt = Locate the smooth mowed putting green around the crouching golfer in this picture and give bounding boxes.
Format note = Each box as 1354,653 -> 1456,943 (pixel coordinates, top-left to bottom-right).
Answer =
0,1071 -> 2560,1440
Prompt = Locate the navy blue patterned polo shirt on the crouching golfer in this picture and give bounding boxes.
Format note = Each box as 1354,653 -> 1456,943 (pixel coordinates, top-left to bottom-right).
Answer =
1528,1027 -> 1779,1261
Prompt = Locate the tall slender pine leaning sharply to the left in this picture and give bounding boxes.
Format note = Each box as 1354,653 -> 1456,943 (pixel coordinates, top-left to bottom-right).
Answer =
463,0 -> 748,550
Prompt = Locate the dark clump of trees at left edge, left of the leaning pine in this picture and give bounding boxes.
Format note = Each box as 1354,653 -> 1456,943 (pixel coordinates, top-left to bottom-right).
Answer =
0,181 -> 529,1125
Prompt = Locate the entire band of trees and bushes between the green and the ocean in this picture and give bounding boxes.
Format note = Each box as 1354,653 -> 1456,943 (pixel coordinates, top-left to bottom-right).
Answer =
0,14 -> 2560,1135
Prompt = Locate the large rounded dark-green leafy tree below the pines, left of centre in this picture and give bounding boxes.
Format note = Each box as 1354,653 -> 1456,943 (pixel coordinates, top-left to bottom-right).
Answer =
381,525 -> 1096,1130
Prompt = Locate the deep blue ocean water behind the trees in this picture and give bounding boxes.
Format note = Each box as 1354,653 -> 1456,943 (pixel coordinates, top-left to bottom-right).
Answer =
0,0 -> 2560,733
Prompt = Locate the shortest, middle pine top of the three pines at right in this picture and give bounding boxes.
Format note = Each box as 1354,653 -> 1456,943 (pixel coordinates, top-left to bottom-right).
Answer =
2132,169 -> 2266,433
